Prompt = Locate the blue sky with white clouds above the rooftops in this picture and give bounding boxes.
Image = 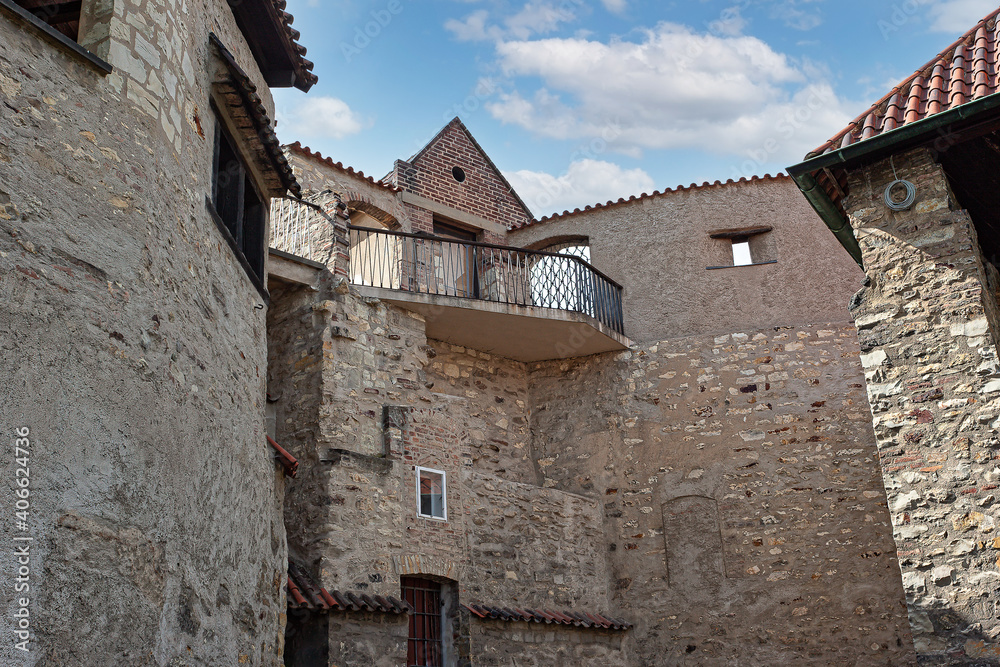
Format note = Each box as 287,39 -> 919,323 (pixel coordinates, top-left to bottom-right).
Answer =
275,0 -> 998,216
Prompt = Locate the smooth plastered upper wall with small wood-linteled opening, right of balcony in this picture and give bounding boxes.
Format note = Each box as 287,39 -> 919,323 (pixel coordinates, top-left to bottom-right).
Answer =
506,177 -> 864,341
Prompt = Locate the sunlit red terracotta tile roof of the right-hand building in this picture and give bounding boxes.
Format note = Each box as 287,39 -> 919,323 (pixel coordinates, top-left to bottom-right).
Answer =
806,9 -> 1000,158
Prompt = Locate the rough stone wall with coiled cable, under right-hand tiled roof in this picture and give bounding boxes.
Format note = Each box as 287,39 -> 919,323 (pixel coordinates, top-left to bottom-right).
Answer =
846,150 -> 1000,664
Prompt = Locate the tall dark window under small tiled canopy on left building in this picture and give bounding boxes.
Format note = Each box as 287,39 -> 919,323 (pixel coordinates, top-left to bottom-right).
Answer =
212,117 -> 267,284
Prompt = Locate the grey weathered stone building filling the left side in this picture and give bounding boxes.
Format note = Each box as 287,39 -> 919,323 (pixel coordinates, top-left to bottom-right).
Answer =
0,0 -> 315,665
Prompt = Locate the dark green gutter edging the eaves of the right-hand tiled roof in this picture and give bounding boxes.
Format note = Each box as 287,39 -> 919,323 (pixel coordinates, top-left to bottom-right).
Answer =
786,93 -> 1000,268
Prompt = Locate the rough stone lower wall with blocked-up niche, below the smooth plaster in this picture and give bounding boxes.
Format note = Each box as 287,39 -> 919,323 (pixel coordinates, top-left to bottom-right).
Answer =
529,323 -> 913,665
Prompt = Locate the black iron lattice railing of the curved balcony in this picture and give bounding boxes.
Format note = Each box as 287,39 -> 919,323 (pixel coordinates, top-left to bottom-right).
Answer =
348,225 -> 625,335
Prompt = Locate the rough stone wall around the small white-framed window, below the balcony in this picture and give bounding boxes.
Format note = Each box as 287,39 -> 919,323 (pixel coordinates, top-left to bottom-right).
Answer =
268,274 -> 610,664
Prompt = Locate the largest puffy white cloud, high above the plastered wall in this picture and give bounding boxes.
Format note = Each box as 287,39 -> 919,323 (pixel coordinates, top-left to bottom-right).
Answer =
487,23 -> 854,163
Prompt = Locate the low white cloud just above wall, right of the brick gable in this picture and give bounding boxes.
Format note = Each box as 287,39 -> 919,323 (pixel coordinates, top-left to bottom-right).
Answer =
506,159 -> 654,217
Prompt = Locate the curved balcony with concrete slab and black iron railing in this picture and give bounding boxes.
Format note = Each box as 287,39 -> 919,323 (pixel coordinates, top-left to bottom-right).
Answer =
348,225 -> 630,361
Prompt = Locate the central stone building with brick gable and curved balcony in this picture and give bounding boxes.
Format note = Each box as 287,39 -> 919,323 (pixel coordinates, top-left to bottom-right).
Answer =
268,119 -> 914,666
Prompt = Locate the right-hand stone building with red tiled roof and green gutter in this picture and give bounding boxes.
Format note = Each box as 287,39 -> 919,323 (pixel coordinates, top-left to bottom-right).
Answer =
789,6 -> 1000,665
